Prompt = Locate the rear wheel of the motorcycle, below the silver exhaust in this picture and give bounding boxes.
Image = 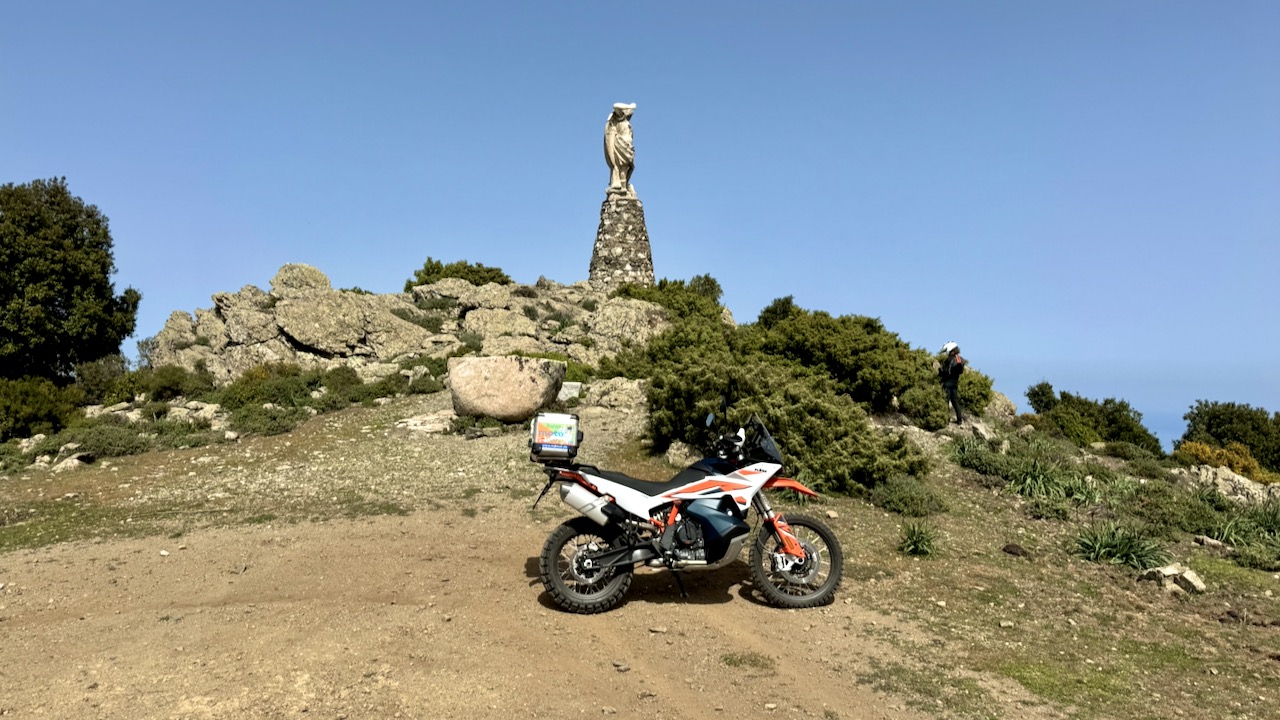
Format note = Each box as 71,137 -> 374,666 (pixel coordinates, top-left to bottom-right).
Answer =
538,518 -> 631,614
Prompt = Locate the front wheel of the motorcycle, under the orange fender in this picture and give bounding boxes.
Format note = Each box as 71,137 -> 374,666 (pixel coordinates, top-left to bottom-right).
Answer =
751,515 -> 845,607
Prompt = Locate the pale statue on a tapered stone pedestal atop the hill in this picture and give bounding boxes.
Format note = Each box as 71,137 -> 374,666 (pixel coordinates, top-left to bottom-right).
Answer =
589,102 -> 653,291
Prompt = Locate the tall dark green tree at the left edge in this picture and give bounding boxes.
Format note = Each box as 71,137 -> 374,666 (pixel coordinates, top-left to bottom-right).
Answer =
0,178 -> 142,382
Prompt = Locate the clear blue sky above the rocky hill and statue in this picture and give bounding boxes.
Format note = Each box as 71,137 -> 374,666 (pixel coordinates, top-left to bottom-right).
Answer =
0,0 -> 1280,446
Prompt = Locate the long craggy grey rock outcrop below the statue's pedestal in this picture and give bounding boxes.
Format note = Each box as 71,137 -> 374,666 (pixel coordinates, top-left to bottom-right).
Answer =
152,264 -> 668,384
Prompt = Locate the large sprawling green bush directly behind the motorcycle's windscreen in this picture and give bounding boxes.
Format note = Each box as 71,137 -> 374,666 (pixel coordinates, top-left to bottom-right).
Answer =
600,277 -> 938,493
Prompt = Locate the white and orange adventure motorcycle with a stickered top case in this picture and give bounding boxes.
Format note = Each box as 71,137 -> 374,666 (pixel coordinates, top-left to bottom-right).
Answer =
530,414 -> 844,612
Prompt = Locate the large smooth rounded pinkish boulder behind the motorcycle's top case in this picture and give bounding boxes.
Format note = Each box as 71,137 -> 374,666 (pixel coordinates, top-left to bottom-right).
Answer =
449,356 -> 566,423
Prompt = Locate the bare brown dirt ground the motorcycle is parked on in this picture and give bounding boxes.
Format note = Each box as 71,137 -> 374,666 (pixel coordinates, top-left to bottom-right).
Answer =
0,506 -> 942,719
